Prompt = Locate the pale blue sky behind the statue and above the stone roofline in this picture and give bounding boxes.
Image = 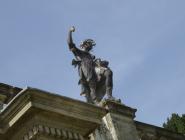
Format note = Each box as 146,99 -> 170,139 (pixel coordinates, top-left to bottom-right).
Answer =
0,0 -> 185,126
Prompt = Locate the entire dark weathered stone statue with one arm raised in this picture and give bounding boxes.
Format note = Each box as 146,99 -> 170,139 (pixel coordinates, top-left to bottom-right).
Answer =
67,27 -> 115,104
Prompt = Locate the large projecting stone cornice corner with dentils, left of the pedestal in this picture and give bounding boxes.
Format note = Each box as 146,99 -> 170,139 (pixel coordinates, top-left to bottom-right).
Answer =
0,88 -> 107,140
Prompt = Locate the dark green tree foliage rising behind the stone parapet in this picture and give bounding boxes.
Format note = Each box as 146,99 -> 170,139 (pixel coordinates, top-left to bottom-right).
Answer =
163,113 -> 185,134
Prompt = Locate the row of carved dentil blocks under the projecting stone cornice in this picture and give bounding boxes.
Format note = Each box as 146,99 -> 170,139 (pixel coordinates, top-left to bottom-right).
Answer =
23,124 -> 84,140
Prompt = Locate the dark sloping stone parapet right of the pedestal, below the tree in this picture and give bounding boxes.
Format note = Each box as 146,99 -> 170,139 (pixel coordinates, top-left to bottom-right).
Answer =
135,121 -> 185,140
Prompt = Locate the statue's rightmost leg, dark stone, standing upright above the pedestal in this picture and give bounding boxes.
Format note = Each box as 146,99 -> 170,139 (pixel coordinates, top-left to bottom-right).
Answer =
104,69 -> 114,99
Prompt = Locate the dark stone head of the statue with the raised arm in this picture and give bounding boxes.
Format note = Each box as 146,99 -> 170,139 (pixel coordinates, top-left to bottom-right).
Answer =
80,39 -> 96,52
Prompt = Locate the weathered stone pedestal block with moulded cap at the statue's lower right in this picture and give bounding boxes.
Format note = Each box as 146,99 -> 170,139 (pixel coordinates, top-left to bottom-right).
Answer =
91,101 -> 139,140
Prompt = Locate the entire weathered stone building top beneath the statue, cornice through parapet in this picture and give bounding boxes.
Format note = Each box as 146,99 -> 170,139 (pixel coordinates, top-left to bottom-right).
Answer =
0,85 -> 185,140
